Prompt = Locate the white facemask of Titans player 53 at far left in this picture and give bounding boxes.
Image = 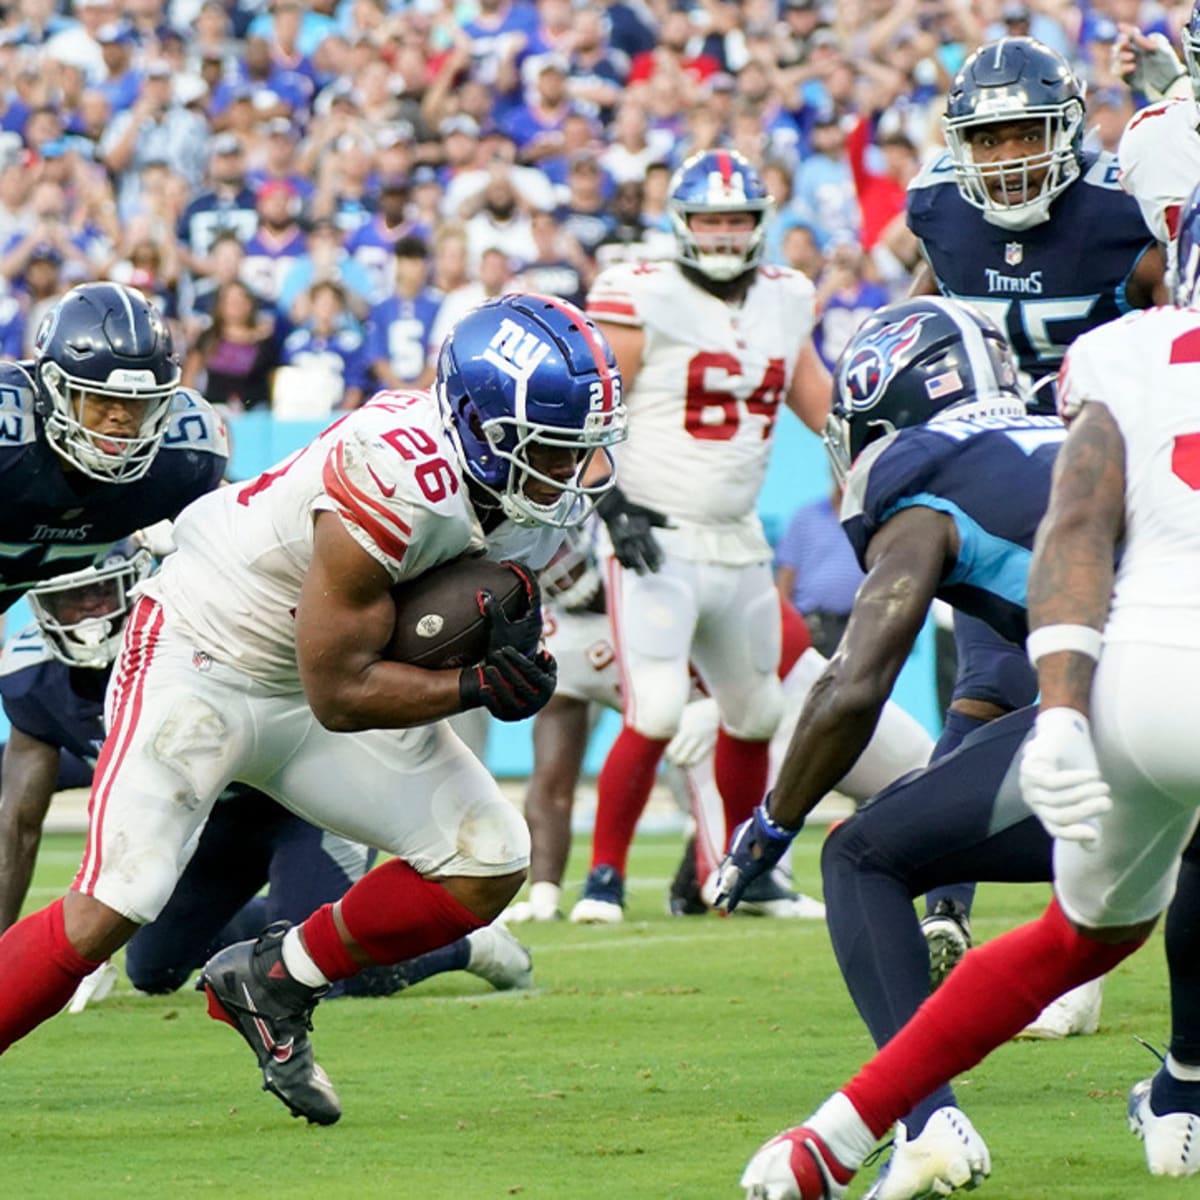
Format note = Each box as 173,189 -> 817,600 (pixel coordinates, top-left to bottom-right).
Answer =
37,359 -> 179,484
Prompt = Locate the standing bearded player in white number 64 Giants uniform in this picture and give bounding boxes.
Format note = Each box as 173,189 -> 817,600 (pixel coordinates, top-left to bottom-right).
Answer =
571,150 -> 829,922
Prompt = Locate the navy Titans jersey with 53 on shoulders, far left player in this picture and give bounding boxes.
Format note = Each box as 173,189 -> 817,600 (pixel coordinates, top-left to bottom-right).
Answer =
0,362 -> 229,612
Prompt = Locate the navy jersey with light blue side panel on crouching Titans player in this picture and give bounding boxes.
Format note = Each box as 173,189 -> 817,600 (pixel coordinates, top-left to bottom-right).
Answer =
841,414 -> 1067,644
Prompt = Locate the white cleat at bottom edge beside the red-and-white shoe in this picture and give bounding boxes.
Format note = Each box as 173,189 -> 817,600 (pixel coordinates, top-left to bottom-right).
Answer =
863,1105 -> 991,1200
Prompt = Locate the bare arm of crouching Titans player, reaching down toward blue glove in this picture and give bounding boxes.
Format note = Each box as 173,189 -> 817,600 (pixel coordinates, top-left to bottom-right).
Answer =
770,508 -> 958,829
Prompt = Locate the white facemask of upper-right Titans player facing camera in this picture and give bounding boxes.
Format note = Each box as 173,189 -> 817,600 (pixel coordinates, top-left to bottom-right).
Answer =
942,103 -> 1084,232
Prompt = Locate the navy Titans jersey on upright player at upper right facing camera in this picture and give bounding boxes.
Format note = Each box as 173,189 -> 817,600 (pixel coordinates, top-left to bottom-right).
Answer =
907,154 -> 1154,379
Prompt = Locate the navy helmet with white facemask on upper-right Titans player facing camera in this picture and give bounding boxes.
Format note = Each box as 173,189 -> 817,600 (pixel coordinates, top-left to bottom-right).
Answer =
942,37 -> 1084,230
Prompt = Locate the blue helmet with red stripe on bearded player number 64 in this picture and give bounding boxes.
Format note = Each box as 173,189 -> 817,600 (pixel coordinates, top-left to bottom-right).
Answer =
667,150 -> 775,282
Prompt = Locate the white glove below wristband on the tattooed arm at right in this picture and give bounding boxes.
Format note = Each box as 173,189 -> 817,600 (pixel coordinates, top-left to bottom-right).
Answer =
1020,708 -> 1112,848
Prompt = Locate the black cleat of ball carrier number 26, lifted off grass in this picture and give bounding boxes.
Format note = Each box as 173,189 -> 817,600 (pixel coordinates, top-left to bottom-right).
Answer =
200,920 -> 342,1124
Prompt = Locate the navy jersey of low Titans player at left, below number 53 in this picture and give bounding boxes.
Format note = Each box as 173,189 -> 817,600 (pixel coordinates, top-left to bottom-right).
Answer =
0,625 -> 108,767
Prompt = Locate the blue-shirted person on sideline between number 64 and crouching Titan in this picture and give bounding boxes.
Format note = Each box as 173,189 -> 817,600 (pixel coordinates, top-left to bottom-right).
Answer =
775,484 -> 864,658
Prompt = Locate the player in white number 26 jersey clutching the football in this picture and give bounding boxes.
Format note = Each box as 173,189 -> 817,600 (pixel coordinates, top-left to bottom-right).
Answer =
0,295 -> 625,1124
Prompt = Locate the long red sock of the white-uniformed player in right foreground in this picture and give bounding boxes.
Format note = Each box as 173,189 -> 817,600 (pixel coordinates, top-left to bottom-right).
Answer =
842,900 -> 1144,1138
